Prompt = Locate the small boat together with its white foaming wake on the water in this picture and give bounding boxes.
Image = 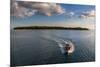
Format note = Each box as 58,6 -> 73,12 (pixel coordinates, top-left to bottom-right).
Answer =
41,36 -> 75,55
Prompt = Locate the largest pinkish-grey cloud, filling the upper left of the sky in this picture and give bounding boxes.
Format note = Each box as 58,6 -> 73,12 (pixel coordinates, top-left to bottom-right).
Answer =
11,0 -> 65,17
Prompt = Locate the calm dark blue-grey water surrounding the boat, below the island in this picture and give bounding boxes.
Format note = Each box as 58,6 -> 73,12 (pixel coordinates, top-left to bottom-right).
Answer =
11,30 -> 95,66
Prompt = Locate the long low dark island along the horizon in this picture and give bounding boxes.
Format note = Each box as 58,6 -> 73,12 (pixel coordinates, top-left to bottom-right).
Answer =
14,26 -> 89,30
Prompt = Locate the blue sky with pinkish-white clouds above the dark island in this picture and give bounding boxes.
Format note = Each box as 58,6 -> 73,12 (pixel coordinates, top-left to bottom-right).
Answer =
11,0 -> 95,29
